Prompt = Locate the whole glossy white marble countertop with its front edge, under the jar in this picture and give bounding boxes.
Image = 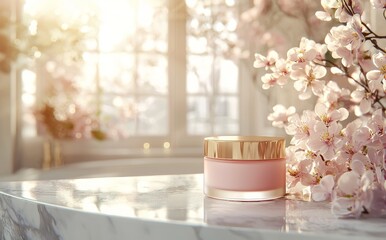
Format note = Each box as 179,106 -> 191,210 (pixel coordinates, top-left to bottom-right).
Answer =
0,174 -> 386,240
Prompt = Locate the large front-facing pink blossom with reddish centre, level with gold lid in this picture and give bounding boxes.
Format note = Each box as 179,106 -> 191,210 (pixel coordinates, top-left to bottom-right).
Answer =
307,122 -> 343,160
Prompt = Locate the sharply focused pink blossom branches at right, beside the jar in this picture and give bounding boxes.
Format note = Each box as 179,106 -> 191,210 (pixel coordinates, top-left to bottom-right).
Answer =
254,0 -> 386,217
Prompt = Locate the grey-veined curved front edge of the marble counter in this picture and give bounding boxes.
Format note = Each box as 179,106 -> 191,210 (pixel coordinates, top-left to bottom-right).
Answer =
0,188 -> 372,240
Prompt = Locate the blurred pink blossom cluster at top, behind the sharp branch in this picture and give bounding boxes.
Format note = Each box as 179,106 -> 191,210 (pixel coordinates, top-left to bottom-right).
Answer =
237,0 -> 331,53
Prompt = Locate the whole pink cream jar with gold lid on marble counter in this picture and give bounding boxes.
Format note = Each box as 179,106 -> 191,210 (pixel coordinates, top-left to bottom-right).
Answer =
204,136 -> 286,201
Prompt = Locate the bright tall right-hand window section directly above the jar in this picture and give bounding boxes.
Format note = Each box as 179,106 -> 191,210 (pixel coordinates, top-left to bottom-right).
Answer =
186,0 -> 246,135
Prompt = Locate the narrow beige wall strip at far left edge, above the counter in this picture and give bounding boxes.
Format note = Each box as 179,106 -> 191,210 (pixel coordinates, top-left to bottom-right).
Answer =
0,73 -> 15,175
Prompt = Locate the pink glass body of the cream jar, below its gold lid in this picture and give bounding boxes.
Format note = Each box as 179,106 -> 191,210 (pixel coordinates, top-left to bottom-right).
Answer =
204,157 -> 286,201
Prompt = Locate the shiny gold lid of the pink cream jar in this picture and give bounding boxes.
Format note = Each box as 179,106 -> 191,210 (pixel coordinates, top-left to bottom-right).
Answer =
204,136 -> 285,160
